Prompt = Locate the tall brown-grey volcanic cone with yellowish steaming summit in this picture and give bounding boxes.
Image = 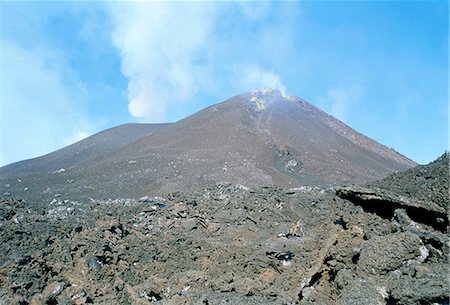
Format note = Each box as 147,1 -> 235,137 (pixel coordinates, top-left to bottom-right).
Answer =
0,89 -> 416,200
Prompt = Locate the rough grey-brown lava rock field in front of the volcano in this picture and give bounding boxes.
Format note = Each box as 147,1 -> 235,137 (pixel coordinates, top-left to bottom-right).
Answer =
0,154 -> 449,305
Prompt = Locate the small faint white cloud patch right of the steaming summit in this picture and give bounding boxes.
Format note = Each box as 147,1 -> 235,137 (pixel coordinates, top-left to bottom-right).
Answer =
317,84 -> 364,122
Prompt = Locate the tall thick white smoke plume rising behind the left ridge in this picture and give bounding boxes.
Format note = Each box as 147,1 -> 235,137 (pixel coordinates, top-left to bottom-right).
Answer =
110,2 -> 215,122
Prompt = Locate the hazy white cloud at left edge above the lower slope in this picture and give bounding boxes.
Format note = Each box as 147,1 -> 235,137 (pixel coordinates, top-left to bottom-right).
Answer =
0,39 -> 90,166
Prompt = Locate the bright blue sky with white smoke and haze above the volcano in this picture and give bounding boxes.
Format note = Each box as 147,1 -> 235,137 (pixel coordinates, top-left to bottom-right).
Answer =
0,1 -> 449,165
